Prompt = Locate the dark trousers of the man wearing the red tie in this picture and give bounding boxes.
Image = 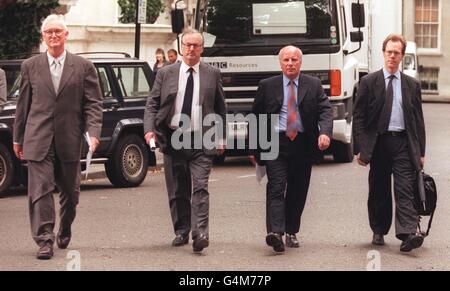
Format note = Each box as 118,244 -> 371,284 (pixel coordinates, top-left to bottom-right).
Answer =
266,133 -> 311,234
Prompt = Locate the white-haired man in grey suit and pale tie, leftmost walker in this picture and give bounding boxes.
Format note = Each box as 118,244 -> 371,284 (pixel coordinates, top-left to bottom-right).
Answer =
14,15 -> 102,259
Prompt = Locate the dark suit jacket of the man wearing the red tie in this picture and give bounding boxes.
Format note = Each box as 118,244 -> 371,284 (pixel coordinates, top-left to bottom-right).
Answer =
252,74 -> 333,163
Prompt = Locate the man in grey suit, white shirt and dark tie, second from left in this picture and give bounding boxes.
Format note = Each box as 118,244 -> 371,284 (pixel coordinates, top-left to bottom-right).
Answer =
144,30 -> 226,252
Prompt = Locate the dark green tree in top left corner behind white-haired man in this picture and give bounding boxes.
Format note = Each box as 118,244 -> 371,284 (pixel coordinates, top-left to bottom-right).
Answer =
0,0 -> 59,59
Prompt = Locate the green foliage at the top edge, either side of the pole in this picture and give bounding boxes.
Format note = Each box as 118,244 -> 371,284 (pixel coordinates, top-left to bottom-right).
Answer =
118,0 -> 165,23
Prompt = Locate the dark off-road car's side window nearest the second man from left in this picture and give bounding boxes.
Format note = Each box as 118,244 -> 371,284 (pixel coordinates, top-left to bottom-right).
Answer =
113,66 -> 150,99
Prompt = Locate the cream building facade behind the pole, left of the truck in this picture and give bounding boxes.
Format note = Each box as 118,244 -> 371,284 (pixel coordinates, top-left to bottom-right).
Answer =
41,0 -> 185,66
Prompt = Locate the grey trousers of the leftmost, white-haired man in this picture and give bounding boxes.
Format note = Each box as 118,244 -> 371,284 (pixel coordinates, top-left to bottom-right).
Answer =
28,145 -> 80,246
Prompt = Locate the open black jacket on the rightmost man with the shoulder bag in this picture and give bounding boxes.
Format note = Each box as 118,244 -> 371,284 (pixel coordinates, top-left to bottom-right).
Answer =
353,70 -> 425,169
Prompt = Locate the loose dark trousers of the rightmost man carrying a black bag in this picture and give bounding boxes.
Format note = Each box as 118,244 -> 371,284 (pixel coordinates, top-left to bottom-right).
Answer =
367,134 -> 419,239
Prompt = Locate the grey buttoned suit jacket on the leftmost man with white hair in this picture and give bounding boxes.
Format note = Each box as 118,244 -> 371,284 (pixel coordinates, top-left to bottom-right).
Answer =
14,52 -> 103,162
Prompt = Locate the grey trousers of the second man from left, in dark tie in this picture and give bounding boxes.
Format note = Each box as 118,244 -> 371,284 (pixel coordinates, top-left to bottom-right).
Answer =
164,149 -> 213,239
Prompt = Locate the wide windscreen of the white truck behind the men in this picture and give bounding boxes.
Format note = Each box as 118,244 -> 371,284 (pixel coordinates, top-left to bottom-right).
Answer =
200,0 -> 339,56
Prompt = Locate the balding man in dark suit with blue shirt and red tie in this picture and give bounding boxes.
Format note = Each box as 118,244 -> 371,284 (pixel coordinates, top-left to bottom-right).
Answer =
251,46 -> 333,252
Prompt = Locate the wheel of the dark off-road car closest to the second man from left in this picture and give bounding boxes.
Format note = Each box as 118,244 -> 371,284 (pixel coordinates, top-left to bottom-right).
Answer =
105,134 -> 148,187
